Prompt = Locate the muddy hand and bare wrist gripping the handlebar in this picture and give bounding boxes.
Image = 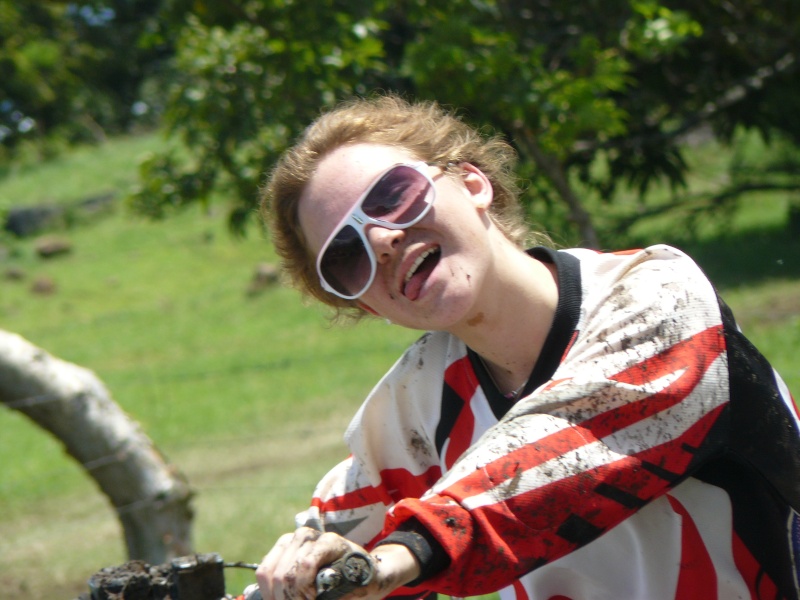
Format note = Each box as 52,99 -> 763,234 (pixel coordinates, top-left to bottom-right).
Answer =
256,527 -> 419,600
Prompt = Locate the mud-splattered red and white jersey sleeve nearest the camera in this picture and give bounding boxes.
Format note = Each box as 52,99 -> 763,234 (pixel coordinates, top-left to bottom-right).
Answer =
384,248 -> 729,597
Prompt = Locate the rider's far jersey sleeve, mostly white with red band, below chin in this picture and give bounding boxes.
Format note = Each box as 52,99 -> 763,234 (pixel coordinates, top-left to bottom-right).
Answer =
296,334 -> 456,546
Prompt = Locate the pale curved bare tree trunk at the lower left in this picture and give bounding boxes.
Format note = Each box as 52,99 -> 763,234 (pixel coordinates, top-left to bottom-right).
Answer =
0,330 -> 192,564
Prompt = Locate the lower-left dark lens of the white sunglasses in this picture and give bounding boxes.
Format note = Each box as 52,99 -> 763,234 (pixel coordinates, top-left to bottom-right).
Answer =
319,225 -> 372,296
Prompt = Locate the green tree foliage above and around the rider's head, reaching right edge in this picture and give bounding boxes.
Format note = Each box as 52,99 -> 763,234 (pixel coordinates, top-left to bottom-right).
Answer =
0,0 -> 800,246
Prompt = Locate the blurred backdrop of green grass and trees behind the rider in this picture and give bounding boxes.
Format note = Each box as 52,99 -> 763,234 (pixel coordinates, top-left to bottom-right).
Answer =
0,0 -> 800,599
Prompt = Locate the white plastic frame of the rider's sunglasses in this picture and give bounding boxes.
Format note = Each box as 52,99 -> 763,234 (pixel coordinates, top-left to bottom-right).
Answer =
317,161 -> 439,300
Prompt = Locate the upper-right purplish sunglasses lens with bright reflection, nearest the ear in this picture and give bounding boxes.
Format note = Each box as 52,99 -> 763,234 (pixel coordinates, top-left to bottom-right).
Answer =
361,165 -> 433,225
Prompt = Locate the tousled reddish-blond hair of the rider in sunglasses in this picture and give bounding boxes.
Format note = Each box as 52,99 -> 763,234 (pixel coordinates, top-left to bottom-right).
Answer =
260,95 -> 531,318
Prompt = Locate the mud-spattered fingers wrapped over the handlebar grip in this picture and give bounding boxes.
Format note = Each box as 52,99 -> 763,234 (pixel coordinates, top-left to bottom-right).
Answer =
256,527 -> 358,600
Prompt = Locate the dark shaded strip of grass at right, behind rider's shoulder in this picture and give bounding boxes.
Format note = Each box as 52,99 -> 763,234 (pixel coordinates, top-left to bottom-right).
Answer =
636,227 -> 800,289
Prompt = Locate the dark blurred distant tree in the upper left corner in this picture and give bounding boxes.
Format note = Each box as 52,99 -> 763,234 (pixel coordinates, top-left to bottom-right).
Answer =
0,0 -> 171,159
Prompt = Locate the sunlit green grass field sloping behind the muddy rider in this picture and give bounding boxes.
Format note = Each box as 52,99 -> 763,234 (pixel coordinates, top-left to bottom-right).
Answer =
0,130 -> 800,600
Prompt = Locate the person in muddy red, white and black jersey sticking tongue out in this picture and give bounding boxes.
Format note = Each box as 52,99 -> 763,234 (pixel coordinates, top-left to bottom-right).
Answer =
257,96 -> 800,600
